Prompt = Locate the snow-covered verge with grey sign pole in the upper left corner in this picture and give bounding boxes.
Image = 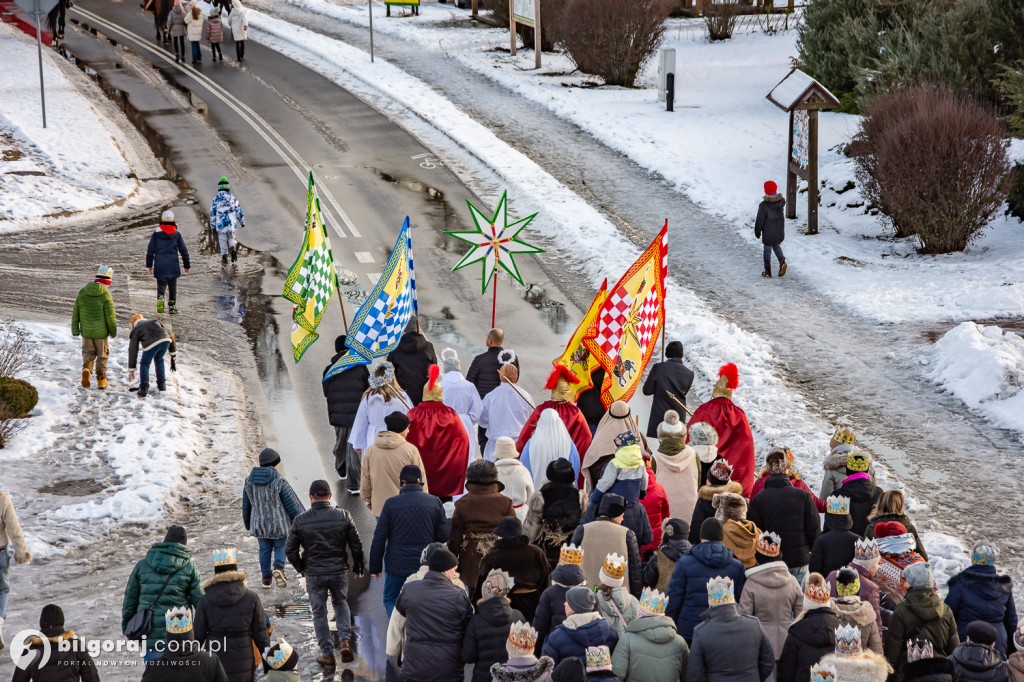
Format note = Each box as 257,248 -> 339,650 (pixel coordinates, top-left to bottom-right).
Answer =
0,24 -> 173,232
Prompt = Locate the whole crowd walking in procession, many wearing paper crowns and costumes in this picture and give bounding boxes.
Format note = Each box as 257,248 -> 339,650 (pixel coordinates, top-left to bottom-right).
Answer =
0,328 -> 1024,682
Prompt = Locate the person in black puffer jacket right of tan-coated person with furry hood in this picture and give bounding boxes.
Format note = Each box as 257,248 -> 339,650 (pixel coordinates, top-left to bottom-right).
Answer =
746,447 -> 819,586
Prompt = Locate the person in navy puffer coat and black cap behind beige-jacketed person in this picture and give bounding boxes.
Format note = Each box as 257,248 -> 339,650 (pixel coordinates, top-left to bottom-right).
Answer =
370,464 -> 450,619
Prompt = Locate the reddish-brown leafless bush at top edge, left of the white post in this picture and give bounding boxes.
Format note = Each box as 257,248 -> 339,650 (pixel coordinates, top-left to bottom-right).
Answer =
560,0 -> 669,87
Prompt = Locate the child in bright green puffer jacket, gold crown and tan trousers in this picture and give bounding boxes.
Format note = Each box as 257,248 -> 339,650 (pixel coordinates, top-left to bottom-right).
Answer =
71,265 -> 118,388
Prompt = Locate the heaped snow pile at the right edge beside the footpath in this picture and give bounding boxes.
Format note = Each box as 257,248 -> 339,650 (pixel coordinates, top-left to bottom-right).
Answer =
926,322 -> 1024,434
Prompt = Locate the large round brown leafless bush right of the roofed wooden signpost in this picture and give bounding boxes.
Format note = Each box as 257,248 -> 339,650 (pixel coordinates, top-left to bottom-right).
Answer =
855,86 -> 1011,253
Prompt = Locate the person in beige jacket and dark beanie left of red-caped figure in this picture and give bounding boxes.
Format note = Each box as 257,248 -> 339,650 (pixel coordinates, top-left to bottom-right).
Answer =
359,412 -> 430,516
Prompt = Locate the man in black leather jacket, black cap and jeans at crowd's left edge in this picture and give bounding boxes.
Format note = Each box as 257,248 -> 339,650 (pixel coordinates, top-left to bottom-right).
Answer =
285,480 -> 362,670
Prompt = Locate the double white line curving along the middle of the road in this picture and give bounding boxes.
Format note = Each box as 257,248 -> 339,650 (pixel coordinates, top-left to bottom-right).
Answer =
72,7 -> 362,239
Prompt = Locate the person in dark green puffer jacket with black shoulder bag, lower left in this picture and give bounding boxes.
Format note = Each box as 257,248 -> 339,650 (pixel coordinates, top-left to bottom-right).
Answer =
121,525 -> 203,663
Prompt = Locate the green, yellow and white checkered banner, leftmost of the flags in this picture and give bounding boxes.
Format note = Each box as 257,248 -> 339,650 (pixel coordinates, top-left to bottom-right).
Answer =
284,173 -> 338,363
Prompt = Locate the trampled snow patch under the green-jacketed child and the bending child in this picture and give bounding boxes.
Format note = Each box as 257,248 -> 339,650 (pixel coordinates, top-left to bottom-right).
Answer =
0,323 -> 248,557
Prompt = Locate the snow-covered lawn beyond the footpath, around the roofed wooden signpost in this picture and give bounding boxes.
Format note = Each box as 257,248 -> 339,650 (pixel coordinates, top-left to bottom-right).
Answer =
270,0 -> 1024,323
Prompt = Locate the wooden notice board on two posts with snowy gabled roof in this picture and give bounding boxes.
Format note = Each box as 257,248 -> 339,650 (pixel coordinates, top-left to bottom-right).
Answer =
768,69 -> 842,235
